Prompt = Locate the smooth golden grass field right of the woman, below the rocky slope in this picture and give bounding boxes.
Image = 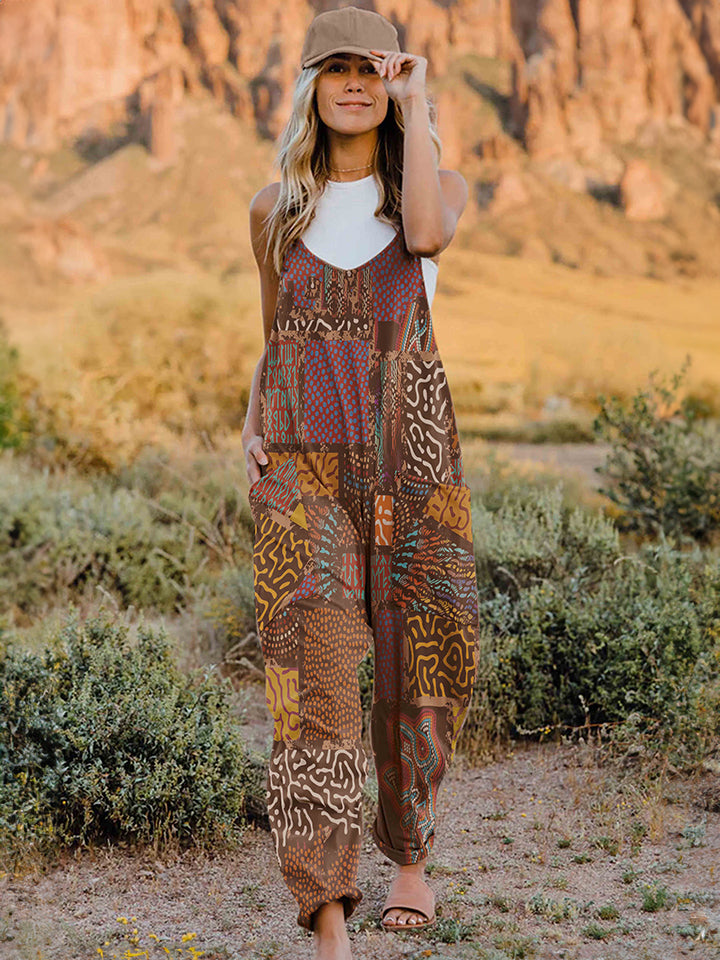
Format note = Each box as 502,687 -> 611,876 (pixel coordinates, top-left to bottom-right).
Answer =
434,249 -> 720,424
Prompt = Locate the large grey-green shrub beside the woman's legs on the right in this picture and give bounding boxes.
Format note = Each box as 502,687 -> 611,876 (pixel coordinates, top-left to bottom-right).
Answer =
462,478 -> 720,764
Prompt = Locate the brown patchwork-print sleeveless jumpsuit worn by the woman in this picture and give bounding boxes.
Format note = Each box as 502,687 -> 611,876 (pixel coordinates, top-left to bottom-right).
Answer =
248,223 -> 479,929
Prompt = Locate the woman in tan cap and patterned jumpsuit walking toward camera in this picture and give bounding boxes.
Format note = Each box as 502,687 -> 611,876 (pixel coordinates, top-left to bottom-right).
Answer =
243,7 -> 478,960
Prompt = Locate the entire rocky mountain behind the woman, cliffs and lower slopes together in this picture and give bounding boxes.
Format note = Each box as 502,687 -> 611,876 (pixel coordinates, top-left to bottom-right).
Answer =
0,0 -> 720,284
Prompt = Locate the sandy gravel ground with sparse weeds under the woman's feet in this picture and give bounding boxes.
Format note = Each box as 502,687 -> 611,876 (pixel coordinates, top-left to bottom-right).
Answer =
0,684 -> 720,960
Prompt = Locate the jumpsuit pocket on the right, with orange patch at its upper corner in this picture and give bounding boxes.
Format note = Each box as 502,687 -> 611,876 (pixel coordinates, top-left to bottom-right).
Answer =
391,472 -> 478,627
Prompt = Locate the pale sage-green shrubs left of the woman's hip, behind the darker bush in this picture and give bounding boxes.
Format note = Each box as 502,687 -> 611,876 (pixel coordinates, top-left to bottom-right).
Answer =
0,457 -> 249,613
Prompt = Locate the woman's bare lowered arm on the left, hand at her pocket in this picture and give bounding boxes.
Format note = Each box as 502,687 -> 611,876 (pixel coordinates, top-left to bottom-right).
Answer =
242,183 -> 280,484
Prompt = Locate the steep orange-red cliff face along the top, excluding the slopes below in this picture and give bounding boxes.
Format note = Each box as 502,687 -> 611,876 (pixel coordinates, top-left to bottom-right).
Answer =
0,0 -> 720,160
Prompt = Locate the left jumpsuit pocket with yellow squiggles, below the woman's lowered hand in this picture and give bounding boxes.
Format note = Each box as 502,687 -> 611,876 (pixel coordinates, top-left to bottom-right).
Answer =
248,453 -> 316,636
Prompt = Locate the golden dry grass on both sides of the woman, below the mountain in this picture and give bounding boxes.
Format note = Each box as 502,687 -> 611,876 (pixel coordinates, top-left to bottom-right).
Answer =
7,250 -> 720,470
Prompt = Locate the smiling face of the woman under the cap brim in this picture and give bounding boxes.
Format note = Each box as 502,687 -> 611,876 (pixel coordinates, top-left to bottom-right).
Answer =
315,53 -> 388,134
